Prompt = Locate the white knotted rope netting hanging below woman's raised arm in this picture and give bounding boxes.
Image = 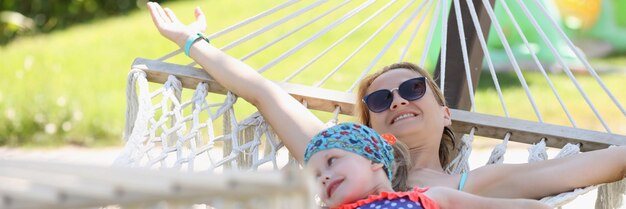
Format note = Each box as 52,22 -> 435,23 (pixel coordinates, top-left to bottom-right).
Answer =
114,70 -> 314,208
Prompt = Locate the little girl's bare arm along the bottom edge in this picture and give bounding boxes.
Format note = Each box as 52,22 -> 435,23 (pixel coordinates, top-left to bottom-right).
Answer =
424,187 -> 550,209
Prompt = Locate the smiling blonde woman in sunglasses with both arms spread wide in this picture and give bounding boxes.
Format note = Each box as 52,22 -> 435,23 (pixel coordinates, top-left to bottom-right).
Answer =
148,3 -> 626,198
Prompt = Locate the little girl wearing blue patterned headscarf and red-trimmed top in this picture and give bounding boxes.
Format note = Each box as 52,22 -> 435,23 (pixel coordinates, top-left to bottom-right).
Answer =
304,123 -> 549,209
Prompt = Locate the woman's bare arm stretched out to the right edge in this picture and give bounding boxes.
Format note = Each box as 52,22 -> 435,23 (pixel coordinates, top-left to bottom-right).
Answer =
463,147 -> 626,199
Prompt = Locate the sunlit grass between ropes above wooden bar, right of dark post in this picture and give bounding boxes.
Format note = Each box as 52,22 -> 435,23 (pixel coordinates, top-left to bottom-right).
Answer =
476,72 -> 626,132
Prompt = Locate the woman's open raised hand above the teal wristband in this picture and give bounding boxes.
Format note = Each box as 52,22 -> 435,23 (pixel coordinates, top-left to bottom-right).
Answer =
148,2 -> 206,47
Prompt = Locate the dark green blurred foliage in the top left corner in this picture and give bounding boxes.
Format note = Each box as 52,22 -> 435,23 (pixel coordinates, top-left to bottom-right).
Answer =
0,0 -> 171,45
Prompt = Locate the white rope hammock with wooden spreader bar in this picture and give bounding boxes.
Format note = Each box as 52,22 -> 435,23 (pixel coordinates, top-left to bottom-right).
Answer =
3,0 -> 626,208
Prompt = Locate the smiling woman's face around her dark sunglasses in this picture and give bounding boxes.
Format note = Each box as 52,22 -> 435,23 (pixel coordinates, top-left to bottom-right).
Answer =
366,68 -> 451,148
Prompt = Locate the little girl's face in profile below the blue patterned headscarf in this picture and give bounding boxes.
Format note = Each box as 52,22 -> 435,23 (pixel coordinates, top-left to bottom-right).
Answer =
308,149 -> 380,208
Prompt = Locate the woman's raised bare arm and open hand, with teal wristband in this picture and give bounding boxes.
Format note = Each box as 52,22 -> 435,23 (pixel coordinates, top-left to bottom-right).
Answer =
148,2 -> 324,162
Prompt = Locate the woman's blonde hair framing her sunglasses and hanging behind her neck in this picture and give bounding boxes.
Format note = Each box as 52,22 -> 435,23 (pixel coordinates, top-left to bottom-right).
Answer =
355,62 -> 455,166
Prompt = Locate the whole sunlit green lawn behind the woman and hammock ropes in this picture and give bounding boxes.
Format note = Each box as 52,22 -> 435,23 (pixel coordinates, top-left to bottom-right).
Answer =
0,0 -> 626,146
